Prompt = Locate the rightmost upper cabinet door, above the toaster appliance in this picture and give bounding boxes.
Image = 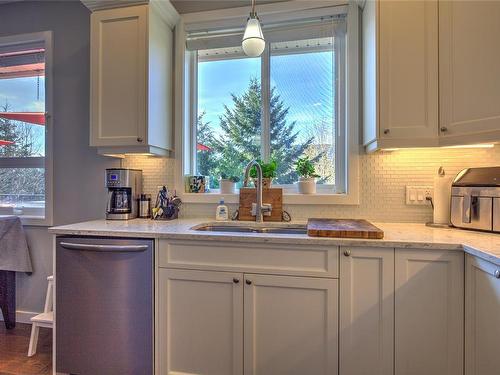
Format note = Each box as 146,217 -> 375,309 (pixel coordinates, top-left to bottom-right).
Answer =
439,1 -> 500,144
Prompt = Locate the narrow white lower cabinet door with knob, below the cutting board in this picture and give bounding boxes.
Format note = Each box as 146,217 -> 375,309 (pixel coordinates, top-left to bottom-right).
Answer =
340,248 -> 394,375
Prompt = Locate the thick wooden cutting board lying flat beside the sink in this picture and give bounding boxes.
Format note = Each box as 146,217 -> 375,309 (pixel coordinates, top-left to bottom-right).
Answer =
307,219 -> 384,239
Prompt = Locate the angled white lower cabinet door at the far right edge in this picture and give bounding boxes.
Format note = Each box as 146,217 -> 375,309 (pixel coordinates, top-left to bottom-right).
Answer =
465,255 -> 500,375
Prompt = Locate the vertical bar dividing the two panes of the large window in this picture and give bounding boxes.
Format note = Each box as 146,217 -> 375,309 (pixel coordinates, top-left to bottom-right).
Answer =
260,43 -> 271,162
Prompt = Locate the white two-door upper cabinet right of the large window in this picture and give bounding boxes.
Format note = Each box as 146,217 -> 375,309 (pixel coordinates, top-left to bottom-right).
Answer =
362,0 -> 500,151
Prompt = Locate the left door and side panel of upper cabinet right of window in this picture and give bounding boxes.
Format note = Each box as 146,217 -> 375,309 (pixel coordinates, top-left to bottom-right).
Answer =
362,1 -> 438,150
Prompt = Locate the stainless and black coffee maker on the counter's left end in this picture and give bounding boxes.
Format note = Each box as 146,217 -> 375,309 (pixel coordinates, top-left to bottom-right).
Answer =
106,168 -> 142,220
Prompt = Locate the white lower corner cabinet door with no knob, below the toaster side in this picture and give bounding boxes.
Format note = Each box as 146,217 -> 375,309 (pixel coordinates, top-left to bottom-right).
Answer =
394,249 -> 464,375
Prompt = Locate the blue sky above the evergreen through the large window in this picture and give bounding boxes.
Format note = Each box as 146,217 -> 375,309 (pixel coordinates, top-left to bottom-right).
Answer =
198,52 -> 333,143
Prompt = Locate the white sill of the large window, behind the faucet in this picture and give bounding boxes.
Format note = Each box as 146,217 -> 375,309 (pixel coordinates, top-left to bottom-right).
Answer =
180,191 -> 359,205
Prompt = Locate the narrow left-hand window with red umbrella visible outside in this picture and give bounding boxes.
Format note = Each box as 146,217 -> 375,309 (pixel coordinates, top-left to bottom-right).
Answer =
0,32 -> 51,224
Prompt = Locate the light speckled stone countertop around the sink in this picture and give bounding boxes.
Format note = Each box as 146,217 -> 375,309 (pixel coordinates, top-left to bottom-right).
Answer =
49,218 -> 500,265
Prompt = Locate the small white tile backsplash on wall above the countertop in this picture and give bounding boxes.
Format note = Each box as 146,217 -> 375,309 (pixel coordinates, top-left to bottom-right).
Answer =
122,145 -> 500,223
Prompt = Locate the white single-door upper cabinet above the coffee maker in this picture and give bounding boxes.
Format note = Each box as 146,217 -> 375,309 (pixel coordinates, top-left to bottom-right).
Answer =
90,2 -> 179,155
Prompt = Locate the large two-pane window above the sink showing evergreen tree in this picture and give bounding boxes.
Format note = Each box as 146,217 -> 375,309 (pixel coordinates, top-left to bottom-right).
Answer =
183,3 -> 357,203
